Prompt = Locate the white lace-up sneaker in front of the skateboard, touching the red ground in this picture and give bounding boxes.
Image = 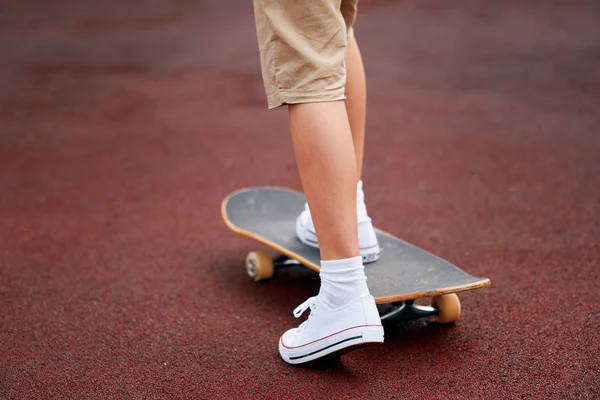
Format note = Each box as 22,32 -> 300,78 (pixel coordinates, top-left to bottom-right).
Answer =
279,296 -> 383,364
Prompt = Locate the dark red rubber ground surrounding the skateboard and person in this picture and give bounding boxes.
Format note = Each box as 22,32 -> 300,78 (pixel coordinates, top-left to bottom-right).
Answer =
0,0 -> 600,399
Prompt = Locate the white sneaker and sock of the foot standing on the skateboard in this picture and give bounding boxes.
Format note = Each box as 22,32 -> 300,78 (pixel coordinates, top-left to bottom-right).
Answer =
296,181 -> 379,264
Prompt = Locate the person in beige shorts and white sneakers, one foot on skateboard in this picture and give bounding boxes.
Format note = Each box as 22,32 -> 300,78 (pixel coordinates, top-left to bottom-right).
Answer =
254,0 -> 383,364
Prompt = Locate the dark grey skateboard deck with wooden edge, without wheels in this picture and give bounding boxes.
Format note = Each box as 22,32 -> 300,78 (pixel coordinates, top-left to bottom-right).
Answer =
221,187 -> 490,304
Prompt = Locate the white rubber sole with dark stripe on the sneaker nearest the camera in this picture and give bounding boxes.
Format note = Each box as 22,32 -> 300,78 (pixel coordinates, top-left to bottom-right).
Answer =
279,325 -> 383,364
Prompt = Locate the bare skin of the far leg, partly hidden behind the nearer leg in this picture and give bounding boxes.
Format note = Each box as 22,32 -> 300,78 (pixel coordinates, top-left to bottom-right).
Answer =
346,36 -> 367,180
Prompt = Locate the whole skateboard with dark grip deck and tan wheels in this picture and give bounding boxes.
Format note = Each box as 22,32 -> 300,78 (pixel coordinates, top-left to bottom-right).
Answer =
221,187 -> 490,323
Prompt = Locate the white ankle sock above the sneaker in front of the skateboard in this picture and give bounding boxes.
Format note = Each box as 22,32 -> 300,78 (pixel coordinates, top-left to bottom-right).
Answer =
319,256 -> 370,310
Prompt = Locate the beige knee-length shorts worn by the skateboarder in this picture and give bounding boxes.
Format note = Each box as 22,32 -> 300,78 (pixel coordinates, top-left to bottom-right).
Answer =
254,0 -> 358,108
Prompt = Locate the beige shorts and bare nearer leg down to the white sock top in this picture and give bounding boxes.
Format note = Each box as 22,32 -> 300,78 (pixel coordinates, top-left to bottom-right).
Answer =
254,0 -> 360,259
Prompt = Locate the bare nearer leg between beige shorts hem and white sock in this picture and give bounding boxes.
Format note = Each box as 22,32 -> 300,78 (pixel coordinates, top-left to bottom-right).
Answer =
289,101 -> 360,260
